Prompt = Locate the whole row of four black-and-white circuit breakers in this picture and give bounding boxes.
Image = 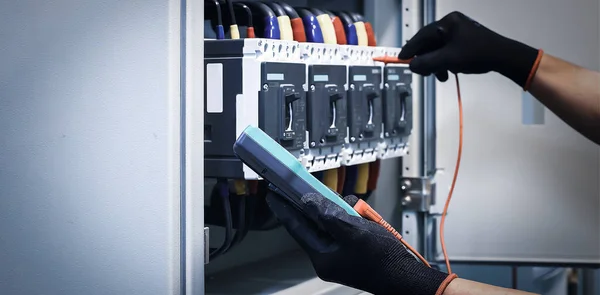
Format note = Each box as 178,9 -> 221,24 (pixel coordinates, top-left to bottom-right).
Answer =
204,39 -> 413,180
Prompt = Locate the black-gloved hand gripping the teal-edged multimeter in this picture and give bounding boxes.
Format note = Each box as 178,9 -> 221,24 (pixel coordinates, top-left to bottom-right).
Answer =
267,193 -> 455,295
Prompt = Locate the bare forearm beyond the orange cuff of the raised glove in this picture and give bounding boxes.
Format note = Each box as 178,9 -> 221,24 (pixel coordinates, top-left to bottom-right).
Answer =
530,54 -> 600,144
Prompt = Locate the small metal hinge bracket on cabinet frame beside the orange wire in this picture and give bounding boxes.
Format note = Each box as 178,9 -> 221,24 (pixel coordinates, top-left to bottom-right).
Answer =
400,177 -> 434,212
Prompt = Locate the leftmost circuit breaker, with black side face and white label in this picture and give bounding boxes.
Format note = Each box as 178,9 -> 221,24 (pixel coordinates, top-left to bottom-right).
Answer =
204,39 -> 306,179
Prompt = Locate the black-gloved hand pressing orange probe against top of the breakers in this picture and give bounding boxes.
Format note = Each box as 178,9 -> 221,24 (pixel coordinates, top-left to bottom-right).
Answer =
398,12 -> 543,89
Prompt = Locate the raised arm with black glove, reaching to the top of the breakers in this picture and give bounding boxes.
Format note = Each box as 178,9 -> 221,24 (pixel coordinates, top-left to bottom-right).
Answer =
399,12 -> 600,144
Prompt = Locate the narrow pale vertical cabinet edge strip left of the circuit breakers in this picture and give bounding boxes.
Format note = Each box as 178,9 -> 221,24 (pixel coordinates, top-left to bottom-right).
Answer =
181,1 -> 205,295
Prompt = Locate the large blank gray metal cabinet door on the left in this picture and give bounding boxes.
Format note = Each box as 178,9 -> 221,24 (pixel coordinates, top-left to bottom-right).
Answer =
0,0 -> 181,295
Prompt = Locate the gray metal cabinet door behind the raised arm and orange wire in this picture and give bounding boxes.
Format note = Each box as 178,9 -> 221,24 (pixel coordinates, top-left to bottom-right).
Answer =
434,0 -> 600,264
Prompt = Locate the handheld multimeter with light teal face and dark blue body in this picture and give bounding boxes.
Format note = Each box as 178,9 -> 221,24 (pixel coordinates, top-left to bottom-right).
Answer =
233,126 -> 360,217
